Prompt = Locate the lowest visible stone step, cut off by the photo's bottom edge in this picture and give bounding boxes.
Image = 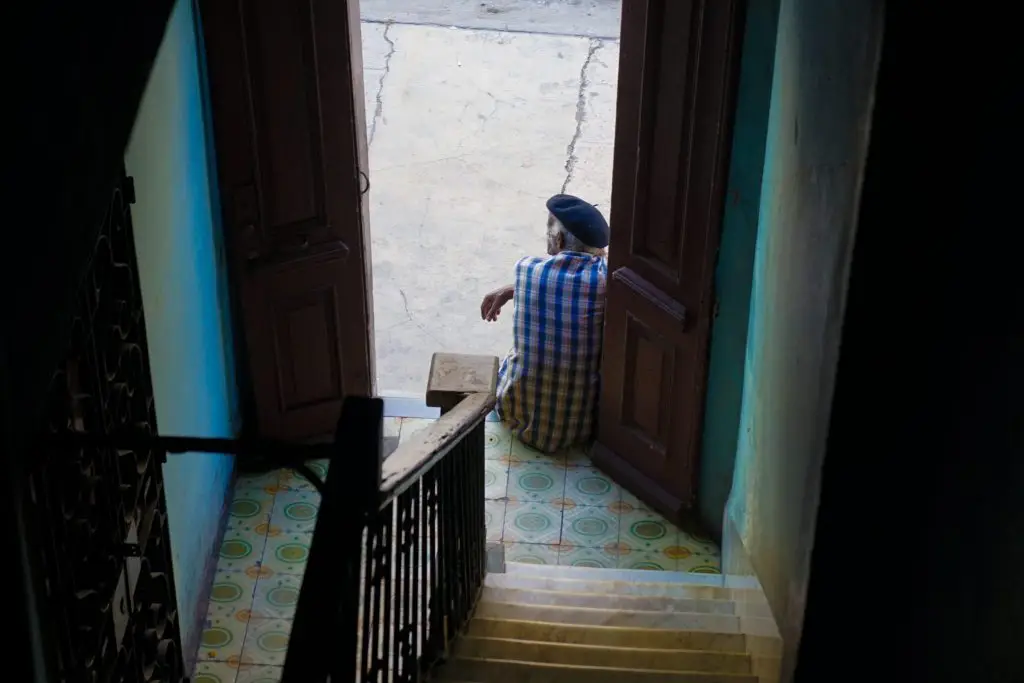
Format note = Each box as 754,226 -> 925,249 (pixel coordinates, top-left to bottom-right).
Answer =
437,657 -> 758,683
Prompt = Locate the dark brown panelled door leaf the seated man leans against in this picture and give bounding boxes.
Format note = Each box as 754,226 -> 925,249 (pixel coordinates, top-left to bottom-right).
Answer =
593,0 -> 741,523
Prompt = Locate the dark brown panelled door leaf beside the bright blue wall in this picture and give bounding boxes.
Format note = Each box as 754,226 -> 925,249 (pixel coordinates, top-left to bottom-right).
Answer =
201,0 -> 374,438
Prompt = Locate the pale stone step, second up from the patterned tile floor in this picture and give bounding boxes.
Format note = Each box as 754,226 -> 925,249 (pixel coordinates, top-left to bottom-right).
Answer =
484,572 -> 732,600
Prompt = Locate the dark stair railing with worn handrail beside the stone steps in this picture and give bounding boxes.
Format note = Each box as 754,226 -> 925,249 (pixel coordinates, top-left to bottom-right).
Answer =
282,393 -> 494,683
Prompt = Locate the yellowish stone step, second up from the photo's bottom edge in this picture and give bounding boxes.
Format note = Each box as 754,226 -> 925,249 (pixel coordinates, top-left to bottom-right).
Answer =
456,636 -> 751,674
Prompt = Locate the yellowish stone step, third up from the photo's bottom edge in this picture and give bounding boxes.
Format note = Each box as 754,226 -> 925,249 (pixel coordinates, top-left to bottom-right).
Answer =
468,613 -> 746,653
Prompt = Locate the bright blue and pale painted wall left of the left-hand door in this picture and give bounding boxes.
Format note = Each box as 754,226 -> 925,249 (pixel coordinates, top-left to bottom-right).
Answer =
125,0 -> 237,659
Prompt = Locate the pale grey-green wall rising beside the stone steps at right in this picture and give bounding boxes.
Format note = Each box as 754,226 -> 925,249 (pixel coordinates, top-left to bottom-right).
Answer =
727,0 -> 884,680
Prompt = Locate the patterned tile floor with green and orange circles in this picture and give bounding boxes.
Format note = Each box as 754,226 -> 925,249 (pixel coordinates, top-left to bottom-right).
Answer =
193,416 -> 720,683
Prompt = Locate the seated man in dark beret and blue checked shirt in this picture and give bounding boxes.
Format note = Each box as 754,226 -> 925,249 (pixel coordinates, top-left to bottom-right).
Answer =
480,195 -> 608,453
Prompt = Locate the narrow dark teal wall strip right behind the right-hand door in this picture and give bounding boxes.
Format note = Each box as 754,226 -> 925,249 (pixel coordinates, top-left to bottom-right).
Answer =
697,0 -> 780,535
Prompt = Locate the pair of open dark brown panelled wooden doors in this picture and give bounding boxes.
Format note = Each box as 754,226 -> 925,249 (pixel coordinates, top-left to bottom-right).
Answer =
200,0 -> 742,521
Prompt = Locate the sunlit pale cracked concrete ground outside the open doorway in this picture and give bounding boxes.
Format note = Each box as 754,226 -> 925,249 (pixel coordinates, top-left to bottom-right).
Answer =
361,10 -> 618,396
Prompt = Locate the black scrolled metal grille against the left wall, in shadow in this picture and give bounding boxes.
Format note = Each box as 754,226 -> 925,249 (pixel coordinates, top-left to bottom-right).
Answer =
29,178 -> 183,683
